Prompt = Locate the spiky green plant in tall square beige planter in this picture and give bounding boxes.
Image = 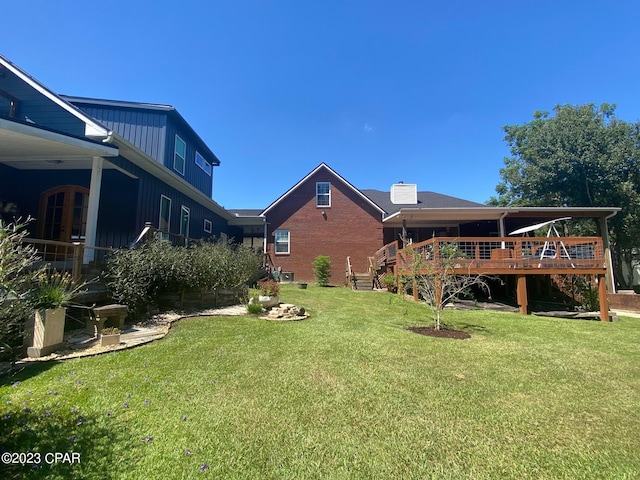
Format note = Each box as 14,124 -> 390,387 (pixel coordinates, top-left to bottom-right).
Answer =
26,271 -> 81,357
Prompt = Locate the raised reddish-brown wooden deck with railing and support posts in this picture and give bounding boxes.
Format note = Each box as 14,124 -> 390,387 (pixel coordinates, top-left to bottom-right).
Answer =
375,237 -> 609,321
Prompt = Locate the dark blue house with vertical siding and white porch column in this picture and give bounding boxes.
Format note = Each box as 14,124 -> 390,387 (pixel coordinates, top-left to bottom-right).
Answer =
0,56 -> 242,258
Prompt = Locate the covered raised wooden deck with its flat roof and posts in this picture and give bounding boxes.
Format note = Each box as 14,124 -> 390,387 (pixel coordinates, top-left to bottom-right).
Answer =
370,207 -> 620,321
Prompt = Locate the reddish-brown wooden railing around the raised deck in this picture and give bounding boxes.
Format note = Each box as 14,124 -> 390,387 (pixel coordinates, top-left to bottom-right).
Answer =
386,237 -> 605,273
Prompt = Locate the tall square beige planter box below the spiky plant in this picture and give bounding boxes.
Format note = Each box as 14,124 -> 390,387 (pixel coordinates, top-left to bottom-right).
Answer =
26,308 -> 66,358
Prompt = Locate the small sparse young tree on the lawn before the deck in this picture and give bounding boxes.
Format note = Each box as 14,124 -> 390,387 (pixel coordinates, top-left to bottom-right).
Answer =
409,242 -> 491,330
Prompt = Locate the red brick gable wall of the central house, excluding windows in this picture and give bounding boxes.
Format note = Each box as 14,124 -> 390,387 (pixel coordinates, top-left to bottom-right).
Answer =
266,169 -> 383,285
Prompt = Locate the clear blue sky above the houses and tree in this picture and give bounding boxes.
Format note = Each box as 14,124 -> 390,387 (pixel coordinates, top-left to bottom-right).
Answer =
5,0 -> 640,208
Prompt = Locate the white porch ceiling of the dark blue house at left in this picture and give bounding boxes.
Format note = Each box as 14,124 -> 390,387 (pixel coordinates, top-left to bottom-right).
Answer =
0,118 -> 118,170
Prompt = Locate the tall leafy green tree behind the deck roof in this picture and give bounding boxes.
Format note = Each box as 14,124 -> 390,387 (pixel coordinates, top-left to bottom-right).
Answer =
487,104 -> 640,286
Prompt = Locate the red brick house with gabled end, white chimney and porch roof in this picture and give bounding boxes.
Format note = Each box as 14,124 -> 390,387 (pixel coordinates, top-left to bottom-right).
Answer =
231,163 -> 619,294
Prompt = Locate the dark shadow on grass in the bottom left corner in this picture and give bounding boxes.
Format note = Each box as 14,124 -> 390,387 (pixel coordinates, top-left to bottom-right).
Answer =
0,405 -> 140,479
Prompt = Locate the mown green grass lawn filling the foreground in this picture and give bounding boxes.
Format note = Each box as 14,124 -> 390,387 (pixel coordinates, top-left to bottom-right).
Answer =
0,286 -> 640,479
